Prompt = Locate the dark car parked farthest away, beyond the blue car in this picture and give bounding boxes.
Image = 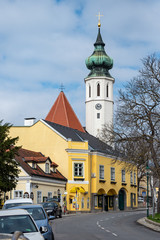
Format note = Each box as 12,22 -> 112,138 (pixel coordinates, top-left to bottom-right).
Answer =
41,201 -> 62,218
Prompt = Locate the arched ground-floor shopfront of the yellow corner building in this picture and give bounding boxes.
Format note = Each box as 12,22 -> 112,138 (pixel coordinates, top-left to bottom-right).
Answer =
67,187 -> 137,212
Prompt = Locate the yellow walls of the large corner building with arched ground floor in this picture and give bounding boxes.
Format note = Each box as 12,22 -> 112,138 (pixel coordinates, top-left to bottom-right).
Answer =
10,121 -> 137,211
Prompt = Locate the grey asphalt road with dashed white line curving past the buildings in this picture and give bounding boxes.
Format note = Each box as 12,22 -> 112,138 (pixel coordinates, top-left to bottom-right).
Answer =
52,211 -> 160,240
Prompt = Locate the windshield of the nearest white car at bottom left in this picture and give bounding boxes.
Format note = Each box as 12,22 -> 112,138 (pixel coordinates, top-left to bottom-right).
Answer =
0,215 -> 38,233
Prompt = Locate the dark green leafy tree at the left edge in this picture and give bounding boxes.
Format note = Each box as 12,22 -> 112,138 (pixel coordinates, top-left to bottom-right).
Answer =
0,120 -> 20,193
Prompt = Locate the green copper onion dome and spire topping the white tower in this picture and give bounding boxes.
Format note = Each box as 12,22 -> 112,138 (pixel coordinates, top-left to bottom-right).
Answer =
85,28 -> 113,77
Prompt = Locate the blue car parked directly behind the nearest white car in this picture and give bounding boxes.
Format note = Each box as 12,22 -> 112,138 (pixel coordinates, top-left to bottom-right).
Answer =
11,204 -> 55,240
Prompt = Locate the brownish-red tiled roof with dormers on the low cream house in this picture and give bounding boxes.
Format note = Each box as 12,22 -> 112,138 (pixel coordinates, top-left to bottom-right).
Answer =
15,148 -> 67,181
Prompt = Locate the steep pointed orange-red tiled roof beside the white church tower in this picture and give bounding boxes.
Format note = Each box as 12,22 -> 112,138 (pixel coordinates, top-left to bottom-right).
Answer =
45,91 -> 85,132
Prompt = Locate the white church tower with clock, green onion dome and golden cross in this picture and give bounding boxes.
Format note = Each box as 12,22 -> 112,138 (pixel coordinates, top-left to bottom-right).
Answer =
85,20 -> 114,137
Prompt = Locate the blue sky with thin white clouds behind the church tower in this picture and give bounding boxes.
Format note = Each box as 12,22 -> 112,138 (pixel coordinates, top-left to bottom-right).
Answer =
0,0 -> 160,126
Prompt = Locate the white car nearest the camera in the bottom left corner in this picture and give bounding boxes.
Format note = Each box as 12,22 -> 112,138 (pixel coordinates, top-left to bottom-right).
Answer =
0,209 -> 44,240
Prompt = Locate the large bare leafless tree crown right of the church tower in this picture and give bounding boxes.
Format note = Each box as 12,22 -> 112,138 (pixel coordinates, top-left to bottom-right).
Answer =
102,54 -> 160,212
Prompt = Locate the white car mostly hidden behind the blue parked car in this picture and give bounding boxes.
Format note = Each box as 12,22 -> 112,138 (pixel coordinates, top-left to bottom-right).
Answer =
2,198 -> 33,209
